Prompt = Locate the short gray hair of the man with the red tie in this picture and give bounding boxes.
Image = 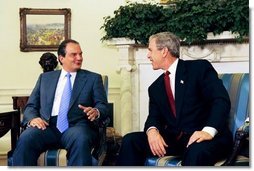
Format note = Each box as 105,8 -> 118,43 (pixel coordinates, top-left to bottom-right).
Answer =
149,32 -> 180,58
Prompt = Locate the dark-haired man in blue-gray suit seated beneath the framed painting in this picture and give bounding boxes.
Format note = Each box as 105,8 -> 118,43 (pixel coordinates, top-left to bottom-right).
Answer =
13,39 -> 108,166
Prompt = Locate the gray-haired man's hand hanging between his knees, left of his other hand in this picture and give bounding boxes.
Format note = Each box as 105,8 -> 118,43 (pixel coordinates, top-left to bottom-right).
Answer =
147,128 -> 168,157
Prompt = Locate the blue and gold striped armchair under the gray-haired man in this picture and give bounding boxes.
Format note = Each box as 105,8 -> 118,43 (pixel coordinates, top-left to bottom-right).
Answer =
145,73 -> 250,166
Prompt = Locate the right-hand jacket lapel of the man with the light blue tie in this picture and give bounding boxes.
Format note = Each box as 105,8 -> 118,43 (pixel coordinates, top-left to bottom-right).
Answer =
69,71 -> 87,108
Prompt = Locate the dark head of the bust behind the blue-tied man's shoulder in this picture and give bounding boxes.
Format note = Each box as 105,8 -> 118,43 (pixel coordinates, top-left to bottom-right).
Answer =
39,52 -> 58,72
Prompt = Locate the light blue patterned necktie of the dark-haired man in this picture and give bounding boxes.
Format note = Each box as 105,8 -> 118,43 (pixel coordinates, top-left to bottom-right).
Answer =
56,73 -> 72,133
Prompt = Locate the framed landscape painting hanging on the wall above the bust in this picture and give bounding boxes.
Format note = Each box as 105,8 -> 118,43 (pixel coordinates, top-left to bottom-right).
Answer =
19,8 -> 71,52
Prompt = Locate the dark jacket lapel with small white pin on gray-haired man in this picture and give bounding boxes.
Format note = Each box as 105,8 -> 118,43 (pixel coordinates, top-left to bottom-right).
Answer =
175,59 -> 186,119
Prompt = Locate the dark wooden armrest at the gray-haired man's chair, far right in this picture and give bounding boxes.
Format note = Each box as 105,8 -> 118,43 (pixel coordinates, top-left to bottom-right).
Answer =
222,117 -> 250,166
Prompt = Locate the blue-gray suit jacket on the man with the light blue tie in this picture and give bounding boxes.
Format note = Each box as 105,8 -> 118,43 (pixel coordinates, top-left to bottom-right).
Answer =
23,70 -> 108,130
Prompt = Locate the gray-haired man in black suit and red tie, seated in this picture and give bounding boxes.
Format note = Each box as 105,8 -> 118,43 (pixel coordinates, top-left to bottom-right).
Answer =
117,32 -> 232,166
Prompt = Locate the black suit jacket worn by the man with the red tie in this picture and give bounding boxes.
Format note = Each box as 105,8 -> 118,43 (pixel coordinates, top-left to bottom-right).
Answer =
144,60 -> 230,140
